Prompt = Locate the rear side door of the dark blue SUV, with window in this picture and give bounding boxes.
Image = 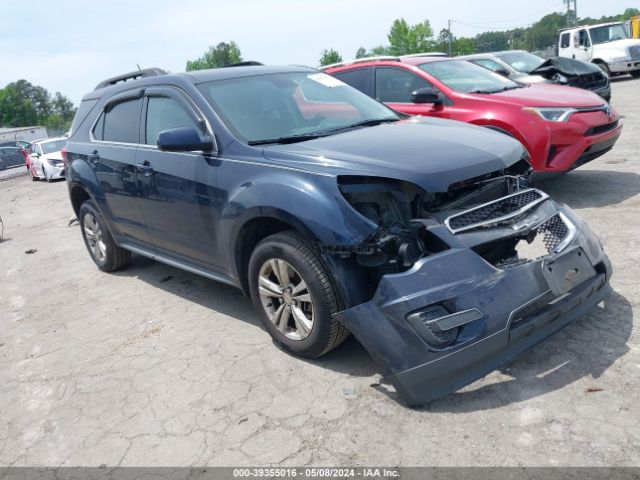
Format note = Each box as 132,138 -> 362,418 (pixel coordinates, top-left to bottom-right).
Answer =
89,90 -> 147,246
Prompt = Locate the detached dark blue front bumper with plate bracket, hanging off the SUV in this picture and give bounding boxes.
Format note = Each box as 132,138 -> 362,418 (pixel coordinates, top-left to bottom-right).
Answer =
339,195 -> 612,406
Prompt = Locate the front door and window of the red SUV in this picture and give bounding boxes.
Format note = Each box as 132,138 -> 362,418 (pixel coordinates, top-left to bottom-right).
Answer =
374,67 -> 449,118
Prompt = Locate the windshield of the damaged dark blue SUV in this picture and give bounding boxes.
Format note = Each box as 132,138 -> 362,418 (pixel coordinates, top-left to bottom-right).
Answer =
200,72 -> 399,144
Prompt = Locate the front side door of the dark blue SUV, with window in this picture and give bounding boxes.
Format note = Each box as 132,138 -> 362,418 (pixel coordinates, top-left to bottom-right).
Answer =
136,87 -> 220,269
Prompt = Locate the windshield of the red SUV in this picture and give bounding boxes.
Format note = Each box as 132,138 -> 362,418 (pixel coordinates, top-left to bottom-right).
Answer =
420,60 -> 521,93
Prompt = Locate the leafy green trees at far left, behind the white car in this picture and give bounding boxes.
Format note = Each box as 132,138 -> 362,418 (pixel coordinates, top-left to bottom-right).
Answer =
0,80 -> 76,134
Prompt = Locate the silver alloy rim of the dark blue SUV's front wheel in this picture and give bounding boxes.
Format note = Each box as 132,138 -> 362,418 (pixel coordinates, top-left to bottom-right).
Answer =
258,258 -> 314,340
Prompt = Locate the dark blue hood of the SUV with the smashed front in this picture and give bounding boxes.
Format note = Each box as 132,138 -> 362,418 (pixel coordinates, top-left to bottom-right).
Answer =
263,117 -> 524,192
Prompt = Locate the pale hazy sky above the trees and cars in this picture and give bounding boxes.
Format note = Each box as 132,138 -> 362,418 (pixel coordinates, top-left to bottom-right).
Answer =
0,0 -> 637,105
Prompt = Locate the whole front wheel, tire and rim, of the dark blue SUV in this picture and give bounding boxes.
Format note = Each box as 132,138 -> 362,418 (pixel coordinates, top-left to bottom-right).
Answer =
248,232 -> 349,358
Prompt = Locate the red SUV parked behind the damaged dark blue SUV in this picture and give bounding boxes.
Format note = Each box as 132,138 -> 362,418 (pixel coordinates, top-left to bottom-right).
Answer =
325,56 -> 622,173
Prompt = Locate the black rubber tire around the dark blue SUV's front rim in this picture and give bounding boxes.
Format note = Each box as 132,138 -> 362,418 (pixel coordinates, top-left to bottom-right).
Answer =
248,231 -> 349,358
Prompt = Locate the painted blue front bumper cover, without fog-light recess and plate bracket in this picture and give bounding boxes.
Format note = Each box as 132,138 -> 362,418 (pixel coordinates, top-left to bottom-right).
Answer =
339,204 -> 612,405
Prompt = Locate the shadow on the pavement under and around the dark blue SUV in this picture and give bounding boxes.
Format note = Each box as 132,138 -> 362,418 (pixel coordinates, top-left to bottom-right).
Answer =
116,255 -> 633,406
